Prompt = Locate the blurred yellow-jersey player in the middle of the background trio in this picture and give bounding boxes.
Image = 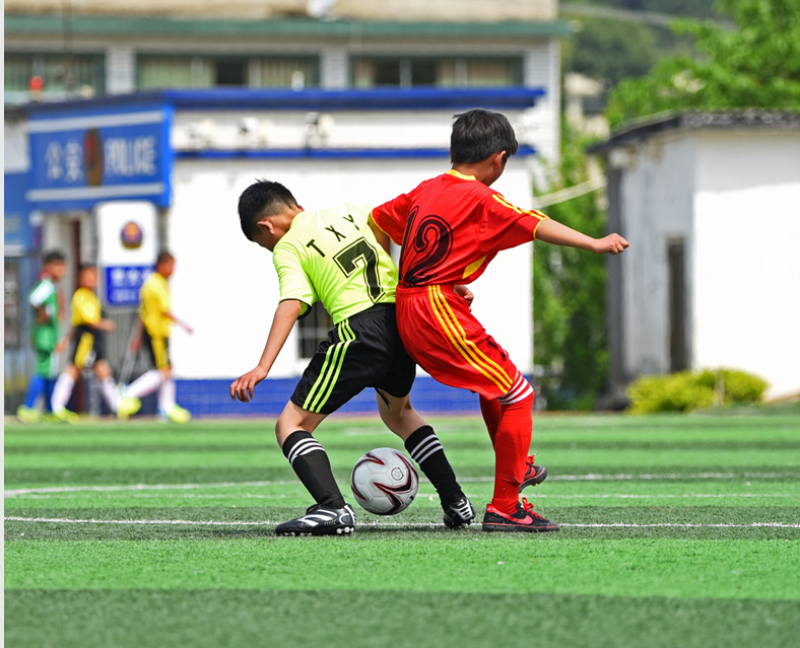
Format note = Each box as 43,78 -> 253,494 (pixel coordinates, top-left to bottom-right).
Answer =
52,264 -> 117,422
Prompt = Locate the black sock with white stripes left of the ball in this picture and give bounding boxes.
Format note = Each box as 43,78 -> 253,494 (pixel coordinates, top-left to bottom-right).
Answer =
282,430 -> 344,508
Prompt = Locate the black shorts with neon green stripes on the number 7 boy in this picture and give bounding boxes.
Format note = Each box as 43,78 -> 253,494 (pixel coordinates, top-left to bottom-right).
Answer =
292,304 -> 416,414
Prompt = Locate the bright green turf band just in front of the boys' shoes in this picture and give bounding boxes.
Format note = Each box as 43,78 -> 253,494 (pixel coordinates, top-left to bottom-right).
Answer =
5,530 -> 800,600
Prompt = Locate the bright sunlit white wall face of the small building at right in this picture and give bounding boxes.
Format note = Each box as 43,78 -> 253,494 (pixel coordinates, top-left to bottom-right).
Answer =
693,133 -> 800,396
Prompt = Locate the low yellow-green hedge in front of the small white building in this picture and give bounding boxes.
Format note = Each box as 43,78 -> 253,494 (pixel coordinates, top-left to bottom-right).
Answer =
628,369 -> 768,414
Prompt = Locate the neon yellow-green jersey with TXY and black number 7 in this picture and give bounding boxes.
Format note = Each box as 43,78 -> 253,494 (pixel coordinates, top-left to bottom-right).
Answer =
273,203 -> 397,324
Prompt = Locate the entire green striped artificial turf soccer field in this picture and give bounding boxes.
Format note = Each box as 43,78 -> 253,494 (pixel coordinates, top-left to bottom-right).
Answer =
4,409 -> 800,648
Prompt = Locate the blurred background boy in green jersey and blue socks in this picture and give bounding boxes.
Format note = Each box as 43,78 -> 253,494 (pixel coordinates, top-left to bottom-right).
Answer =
17,250 -> 67,423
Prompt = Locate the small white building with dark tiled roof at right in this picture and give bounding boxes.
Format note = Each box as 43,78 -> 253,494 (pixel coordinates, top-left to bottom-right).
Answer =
593,110 -> 800,397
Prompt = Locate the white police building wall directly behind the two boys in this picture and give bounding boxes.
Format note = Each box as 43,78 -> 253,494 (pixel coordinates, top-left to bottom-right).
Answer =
168,154 -> 532,378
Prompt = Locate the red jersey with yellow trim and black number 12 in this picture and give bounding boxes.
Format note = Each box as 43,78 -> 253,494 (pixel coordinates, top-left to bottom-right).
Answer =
372,170 -> 547,287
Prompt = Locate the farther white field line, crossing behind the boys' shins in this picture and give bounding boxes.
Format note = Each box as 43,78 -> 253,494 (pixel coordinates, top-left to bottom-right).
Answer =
3,473 -> 788,497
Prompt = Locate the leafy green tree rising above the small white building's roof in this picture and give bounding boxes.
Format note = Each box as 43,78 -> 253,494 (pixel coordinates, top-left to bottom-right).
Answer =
606,0 -> 800,127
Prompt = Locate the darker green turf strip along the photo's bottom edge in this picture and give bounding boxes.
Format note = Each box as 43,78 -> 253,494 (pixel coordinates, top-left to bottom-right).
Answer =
5,589 -> 800,648
